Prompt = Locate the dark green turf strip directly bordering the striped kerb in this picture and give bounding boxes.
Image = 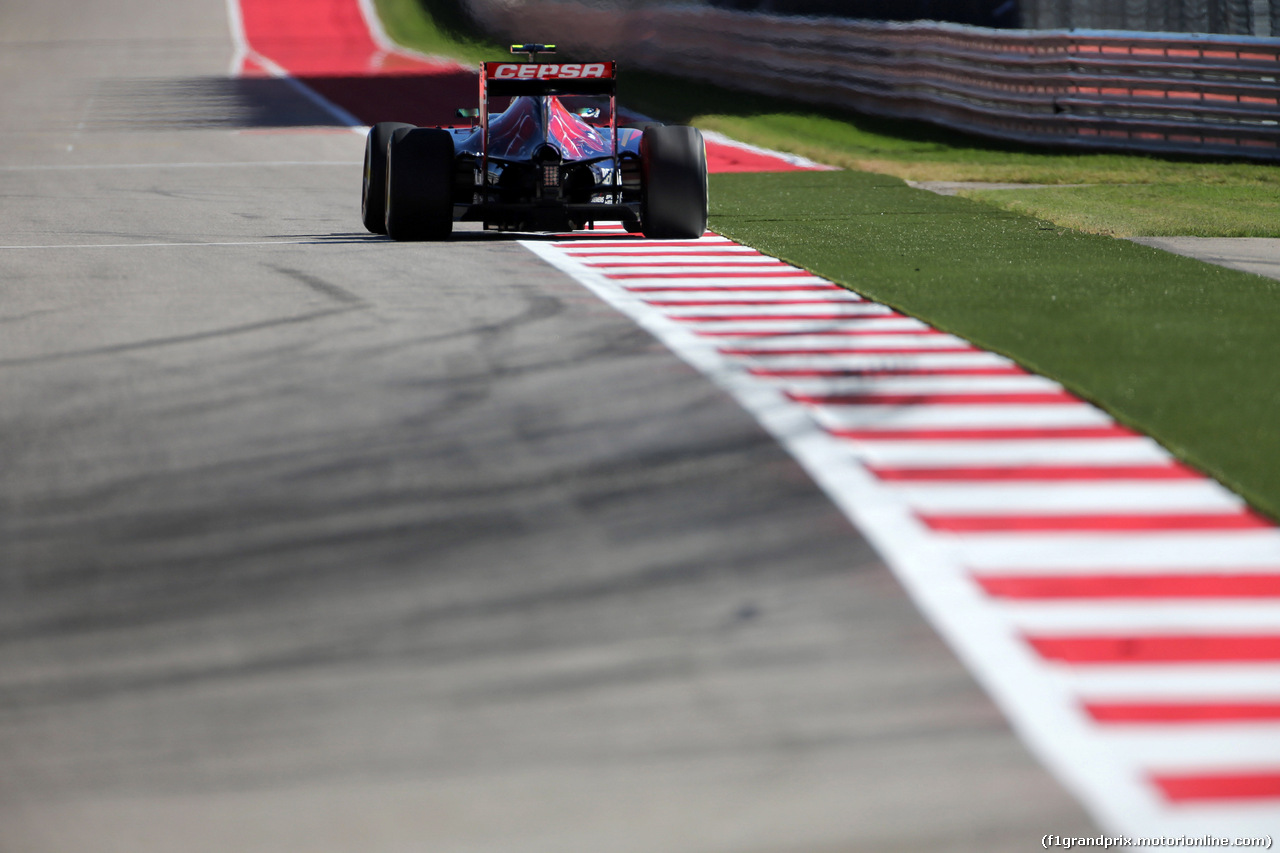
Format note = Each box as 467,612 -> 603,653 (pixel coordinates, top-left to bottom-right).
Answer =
712,172 -> 1280,516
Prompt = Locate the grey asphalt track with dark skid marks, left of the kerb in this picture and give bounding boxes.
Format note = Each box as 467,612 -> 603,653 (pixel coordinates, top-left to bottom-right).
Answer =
0,0 -> 1094,853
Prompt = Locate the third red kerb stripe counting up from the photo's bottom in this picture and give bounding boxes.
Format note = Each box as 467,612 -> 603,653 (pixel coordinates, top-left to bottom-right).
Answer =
1027,634 -> 1280,663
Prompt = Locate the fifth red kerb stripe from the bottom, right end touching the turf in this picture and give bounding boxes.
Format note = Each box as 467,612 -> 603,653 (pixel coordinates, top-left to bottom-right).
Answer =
920,511 -> 1271,533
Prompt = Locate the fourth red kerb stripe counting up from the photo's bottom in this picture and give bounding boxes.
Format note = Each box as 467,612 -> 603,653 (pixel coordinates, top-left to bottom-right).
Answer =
974,573 -> 1280,601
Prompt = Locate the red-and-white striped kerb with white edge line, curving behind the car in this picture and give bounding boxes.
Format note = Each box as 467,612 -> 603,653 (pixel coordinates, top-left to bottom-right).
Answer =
525,224 -> 1280,838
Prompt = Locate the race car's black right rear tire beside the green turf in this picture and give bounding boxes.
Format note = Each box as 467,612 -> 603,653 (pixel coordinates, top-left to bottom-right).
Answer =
640,127 -> 707,240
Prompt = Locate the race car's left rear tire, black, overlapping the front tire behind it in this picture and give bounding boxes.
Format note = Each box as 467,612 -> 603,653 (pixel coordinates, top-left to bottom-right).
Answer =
387,128 -> 453,240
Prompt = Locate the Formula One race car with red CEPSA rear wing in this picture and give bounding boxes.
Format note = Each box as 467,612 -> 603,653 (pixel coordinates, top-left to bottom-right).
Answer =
361,45 -> 707,240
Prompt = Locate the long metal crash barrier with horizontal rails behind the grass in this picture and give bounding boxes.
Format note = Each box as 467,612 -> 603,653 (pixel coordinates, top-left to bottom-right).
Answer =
458,0 -> 1280,160
